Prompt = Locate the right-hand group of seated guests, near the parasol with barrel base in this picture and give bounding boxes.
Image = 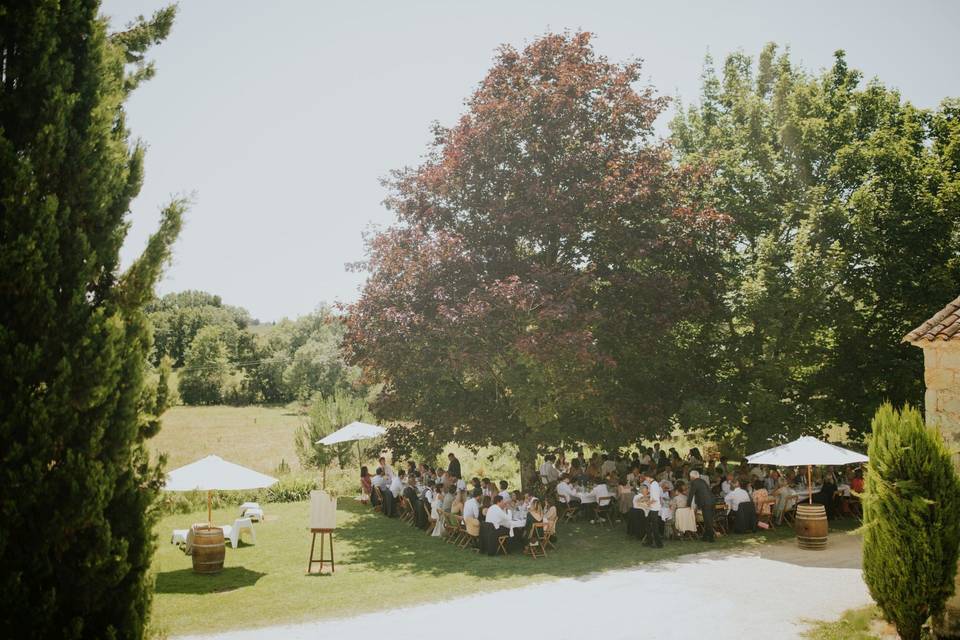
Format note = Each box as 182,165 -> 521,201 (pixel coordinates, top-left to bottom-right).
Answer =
538,444 -> 863,546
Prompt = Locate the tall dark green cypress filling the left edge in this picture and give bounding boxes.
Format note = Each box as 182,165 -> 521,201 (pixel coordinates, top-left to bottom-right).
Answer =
0,0 -> 185,638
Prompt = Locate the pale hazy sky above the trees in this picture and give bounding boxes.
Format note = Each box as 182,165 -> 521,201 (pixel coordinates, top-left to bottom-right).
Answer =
103,0 -> 960,321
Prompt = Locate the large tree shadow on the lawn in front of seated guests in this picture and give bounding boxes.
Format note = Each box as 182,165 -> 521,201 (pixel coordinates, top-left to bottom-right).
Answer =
337,503 -> 808,578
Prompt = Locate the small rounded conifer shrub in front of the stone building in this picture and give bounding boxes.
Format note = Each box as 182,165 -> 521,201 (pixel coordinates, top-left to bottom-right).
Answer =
863,404 -> 960,640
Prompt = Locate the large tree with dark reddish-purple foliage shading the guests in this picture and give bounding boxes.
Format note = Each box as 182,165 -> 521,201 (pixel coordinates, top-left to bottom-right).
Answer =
346,28 -> 723,480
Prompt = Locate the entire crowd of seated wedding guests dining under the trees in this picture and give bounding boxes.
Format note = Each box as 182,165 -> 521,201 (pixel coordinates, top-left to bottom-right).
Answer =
360,444 -> 863,554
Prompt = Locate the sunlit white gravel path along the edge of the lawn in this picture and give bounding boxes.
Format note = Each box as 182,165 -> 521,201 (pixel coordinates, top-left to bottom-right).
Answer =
174,534 -> 870,640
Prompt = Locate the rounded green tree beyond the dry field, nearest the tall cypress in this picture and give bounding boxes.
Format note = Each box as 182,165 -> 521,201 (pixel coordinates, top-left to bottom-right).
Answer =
179,325 -> 233,404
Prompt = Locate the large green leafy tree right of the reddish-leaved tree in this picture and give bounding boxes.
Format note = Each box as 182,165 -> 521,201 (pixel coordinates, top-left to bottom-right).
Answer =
672,45 -> 960,448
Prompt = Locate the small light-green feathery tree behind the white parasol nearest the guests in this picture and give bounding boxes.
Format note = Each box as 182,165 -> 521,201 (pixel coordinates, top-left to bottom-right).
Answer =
294,391 -> 373,487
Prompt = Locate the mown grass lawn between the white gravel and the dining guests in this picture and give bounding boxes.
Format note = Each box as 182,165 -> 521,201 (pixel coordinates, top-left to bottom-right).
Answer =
152,498 -> 816,635
